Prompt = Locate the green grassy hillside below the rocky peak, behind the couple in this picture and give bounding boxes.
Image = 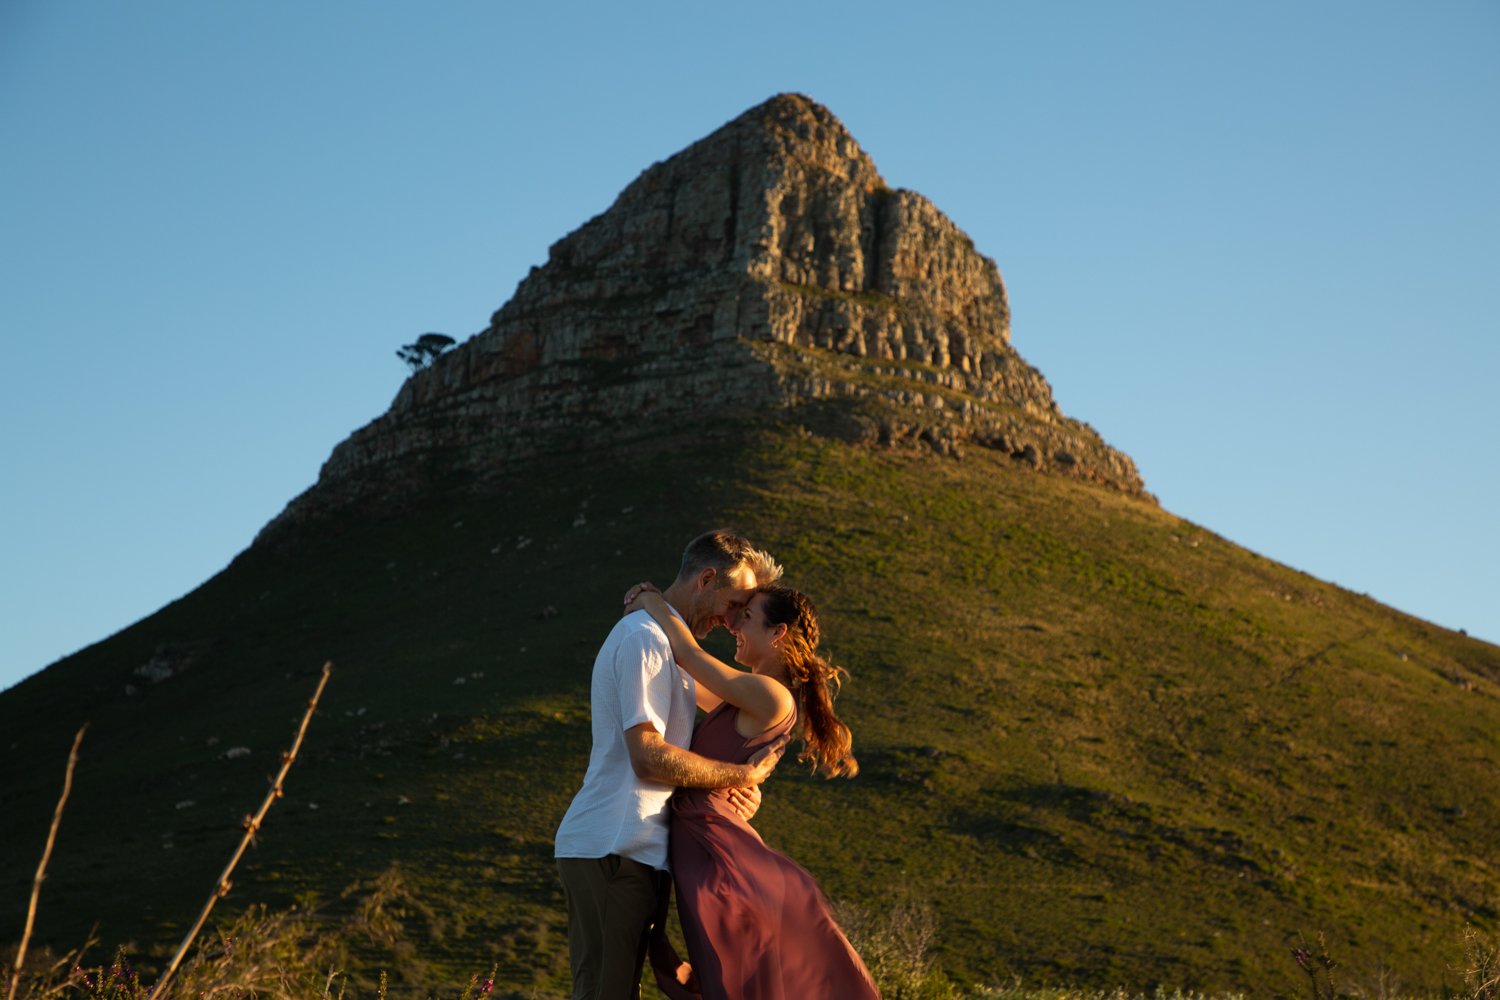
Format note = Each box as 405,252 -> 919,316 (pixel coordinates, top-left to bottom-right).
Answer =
0,426 -> 1500,996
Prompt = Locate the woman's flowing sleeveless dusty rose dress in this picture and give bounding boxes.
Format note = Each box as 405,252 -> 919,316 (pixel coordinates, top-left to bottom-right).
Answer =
657,703 -> 881,1000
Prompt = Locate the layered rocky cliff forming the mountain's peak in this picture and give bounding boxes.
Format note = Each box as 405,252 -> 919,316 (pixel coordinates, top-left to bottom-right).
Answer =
261,94 -> 1145,539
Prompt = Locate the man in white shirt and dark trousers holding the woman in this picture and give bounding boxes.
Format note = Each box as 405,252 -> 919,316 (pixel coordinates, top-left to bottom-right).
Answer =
554,529 -> 782,1000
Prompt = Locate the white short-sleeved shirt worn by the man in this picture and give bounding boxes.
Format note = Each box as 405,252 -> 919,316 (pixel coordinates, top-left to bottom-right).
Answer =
554,610 -> 698,870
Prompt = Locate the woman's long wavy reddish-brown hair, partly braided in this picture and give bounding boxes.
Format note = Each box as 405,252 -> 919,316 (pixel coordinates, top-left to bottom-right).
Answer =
758,586 -> 860,778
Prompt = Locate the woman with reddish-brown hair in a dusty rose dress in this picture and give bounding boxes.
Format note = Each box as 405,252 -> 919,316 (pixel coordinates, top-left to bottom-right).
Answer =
626,583 -> 881,1000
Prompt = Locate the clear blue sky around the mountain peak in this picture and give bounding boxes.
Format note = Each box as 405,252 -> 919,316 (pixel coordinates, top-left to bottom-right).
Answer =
0,0 -> 1500,688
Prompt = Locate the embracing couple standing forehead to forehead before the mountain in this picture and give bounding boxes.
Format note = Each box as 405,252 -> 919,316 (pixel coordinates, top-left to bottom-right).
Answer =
555,531 -> 879,1000
